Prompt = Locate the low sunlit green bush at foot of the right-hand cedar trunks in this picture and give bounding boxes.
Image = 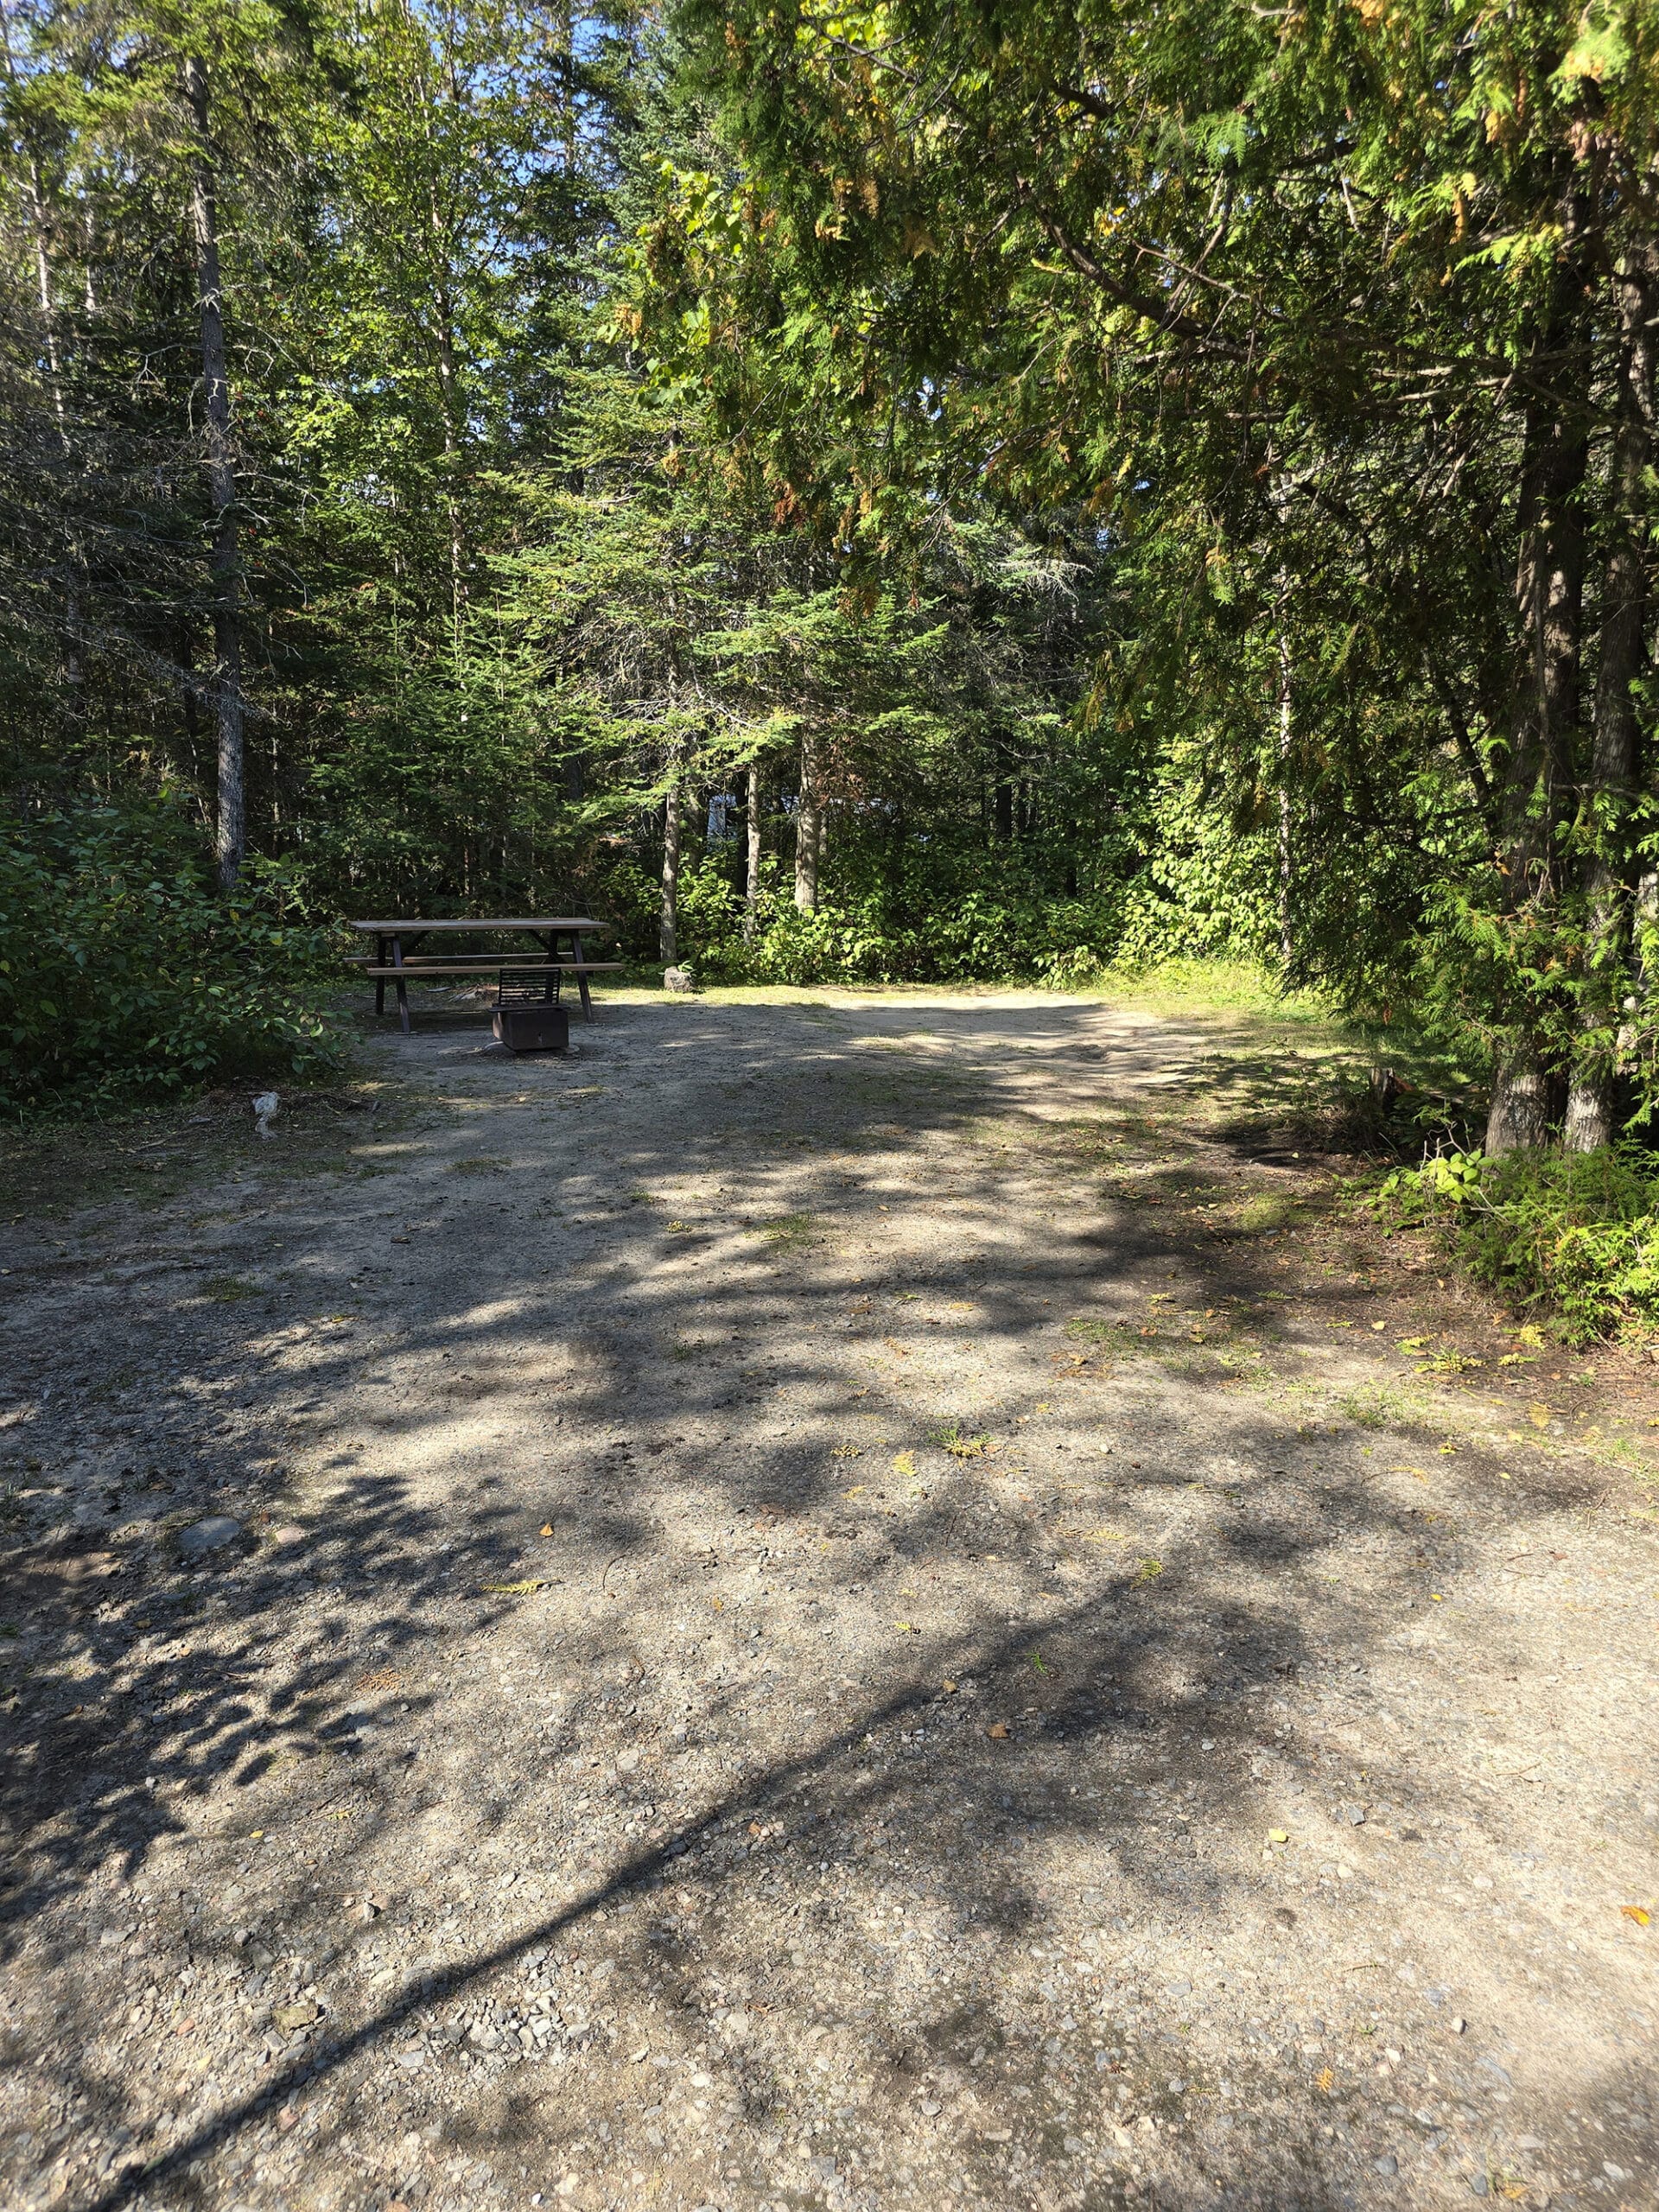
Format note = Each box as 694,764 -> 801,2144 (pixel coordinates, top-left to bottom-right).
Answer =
1376,1146 -> 1659,1344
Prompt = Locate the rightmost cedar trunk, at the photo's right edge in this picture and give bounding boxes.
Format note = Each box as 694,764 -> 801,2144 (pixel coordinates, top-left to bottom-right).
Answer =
1564,238 -> 1659,1153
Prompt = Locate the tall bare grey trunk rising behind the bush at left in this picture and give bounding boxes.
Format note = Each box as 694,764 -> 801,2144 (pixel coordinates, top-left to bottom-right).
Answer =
183,58 -> 248,885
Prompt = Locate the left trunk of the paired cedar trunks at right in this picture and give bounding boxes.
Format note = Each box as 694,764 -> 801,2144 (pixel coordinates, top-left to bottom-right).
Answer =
1486,190 -> 1591,1154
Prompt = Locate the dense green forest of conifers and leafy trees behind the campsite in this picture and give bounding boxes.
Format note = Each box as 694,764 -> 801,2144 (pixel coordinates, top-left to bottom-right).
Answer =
0,0 -> 1659,1150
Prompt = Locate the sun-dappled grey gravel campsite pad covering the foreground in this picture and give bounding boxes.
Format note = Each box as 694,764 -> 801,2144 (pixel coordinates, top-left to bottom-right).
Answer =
0,993 -> 1659,2212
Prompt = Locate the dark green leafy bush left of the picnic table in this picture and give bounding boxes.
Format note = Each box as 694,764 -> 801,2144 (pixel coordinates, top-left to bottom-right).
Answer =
0,803 -> 336,1115
